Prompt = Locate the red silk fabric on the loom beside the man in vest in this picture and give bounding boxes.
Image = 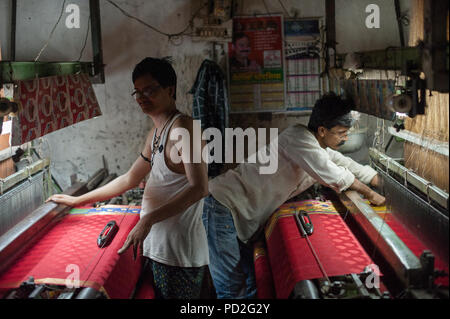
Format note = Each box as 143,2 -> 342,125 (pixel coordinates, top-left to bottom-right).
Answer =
0,205 -> 152,298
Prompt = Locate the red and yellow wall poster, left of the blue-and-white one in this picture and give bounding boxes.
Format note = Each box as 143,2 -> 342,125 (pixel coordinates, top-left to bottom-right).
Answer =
228,15 -> 285,113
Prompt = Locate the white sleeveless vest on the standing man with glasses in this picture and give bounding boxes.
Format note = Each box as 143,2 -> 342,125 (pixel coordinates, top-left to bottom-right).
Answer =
141,114 -> 209,267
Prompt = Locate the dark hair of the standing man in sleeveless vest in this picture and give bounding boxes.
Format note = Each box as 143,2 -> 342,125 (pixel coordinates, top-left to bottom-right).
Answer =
132,57 -> 177,100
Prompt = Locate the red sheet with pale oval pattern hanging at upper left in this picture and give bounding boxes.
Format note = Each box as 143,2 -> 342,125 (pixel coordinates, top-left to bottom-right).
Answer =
11,74 -> 102,145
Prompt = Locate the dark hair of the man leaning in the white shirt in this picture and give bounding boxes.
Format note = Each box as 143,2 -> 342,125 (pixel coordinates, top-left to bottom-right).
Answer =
308,92 -> 353,132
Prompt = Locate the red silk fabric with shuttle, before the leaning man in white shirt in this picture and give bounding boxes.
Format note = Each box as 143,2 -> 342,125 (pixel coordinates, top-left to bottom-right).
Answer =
265,200 -> 381,299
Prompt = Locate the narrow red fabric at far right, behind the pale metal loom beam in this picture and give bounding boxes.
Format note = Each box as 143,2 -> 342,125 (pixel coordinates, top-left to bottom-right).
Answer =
374,206 -> 449,287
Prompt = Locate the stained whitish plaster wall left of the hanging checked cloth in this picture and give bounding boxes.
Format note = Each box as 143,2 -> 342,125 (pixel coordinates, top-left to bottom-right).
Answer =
0,0 -> 209,189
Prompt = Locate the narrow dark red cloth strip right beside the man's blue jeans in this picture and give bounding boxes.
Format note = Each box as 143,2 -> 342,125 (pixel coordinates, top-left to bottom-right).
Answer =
253,241 -> 276,299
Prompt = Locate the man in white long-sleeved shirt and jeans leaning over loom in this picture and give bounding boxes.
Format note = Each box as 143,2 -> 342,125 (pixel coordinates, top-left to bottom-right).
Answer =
203,93 -> 385,298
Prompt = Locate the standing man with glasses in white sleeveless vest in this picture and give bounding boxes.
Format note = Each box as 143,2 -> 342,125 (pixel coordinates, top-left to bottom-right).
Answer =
49,58 -> 210,299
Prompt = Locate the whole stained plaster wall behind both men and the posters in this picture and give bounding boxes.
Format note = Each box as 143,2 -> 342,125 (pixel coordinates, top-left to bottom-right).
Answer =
0,0 -> 410,188
